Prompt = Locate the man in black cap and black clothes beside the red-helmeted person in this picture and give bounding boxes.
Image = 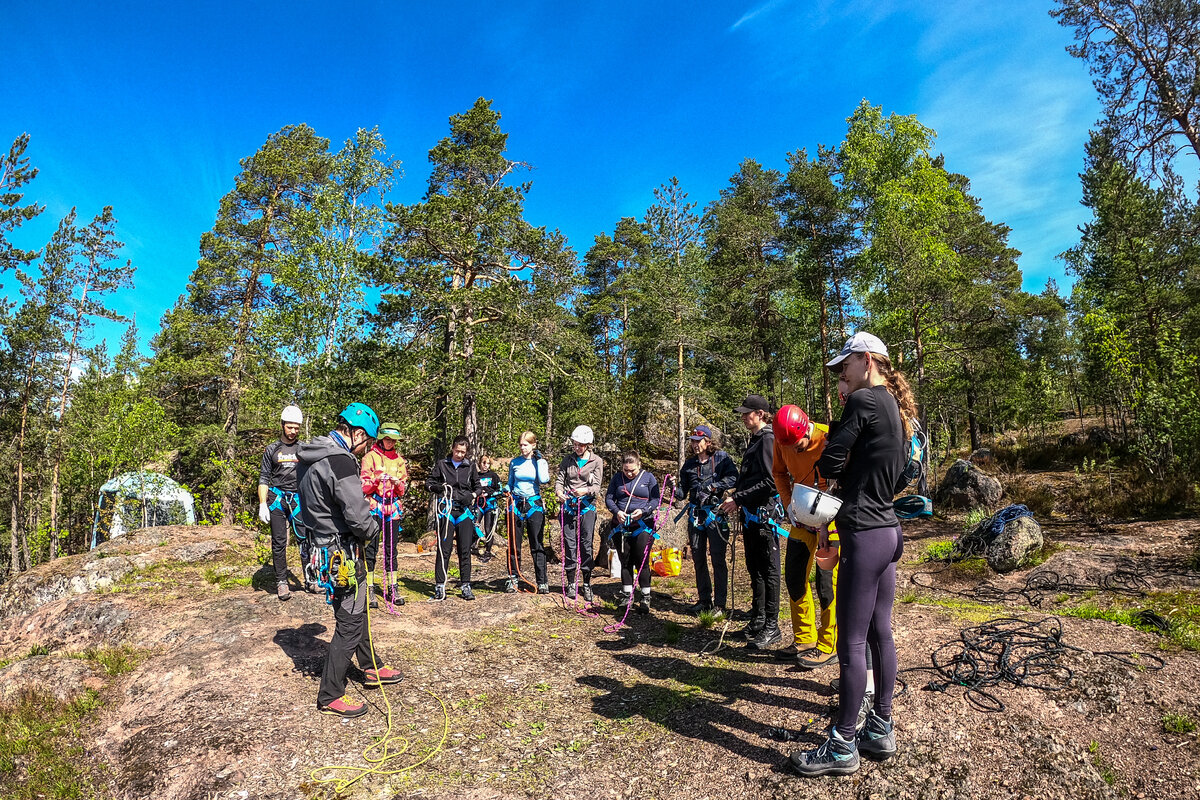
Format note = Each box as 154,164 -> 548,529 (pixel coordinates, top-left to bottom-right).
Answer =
720,395 -> 784,650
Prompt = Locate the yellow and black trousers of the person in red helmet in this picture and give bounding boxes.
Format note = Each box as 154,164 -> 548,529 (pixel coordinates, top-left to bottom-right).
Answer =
784,525 -> 838,652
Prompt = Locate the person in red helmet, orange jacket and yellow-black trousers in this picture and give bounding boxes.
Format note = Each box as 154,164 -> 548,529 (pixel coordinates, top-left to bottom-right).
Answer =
770,405 -> 838,669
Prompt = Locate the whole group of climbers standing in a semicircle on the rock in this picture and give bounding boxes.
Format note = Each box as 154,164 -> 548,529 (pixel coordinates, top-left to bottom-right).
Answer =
259,333 -> 916,776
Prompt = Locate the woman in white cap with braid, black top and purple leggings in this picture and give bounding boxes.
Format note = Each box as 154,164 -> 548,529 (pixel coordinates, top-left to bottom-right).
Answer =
790,332 -> 917,776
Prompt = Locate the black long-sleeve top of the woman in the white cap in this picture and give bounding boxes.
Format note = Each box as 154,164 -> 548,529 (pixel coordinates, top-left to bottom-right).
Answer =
817,386 -> 907,535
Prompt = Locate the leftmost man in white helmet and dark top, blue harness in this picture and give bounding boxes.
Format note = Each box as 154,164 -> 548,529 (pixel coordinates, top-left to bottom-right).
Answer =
258,405 -> 305,600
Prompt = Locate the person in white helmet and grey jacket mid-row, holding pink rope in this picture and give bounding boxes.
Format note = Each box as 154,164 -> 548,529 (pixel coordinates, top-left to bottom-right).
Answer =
554,425 -> 604,602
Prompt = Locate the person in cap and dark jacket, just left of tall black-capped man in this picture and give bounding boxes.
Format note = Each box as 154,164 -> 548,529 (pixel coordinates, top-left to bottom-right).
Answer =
679,425 -> 738,614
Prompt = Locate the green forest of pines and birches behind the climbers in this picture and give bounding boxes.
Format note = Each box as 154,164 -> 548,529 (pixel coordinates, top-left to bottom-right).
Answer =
0,0 -> 1200,576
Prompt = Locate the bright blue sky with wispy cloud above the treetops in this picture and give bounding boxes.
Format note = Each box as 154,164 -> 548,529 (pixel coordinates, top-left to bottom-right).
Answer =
7,0 -> 1099,343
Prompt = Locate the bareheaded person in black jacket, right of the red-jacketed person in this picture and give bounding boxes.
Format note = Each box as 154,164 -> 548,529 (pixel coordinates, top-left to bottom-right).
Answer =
425,437 -> 482,600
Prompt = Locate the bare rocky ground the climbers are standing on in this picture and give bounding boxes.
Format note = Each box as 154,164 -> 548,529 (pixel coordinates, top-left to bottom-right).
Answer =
0,503 -> 1200,800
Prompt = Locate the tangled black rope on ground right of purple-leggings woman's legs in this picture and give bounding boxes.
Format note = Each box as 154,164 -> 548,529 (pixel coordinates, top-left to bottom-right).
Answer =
900,616 -> 1166,712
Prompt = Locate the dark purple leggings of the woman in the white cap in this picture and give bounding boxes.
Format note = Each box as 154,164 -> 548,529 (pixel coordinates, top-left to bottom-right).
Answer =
838,524 -> 904,739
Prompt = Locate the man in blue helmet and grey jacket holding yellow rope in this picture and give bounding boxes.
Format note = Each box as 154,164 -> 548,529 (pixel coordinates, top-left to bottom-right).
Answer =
298,403 -> 402,717
